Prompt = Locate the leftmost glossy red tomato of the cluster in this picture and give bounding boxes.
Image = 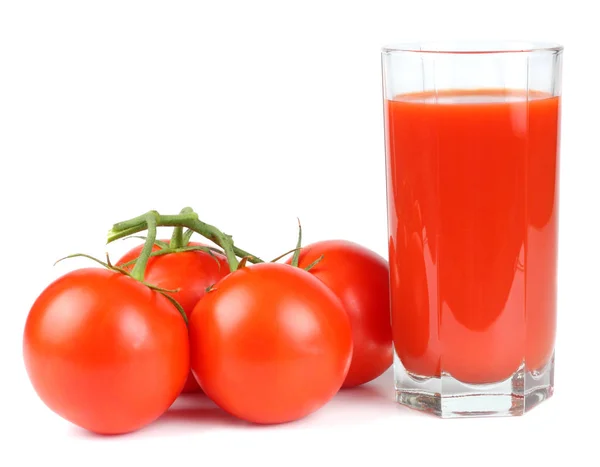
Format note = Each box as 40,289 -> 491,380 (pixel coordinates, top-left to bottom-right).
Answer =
23,268 -> 189,434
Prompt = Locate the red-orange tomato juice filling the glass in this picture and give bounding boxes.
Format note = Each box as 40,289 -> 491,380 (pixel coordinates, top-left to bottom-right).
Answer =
385,89 -> 560,383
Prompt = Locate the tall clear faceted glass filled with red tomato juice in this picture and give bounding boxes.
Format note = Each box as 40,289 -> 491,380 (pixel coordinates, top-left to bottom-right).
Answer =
382,43 -> 562,417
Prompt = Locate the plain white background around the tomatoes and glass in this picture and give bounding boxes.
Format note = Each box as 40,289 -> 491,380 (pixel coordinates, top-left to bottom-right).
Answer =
0,0 -> 600,466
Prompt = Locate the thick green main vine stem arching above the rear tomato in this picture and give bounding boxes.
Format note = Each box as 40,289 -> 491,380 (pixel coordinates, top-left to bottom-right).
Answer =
107,212 -> 263,271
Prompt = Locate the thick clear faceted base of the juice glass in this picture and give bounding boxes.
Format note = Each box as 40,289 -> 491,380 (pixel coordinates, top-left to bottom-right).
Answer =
394,354 -> 554,418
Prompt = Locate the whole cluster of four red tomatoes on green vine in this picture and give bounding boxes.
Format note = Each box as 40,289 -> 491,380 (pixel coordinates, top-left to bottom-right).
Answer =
23,208 -> 392,434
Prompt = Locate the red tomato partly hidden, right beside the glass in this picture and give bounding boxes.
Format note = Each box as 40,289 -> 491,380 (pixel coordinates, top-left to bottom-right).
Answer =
288,240 -> 393,387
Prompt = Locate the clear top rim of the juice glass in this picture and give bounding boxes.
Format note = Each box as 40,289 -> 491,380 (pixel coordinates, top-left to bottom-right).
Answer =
381,40 -> 563,55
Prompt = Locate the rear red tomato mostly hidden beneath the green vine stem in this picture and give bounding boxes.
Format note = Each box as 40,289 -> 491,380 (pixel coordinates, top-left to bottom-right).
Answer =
117,240 -> 229,392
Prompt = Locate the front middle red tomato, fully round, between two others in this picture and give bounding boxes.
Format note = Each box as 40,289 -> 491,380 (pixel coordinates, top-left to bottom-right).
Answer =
189,263 -> 352,424
